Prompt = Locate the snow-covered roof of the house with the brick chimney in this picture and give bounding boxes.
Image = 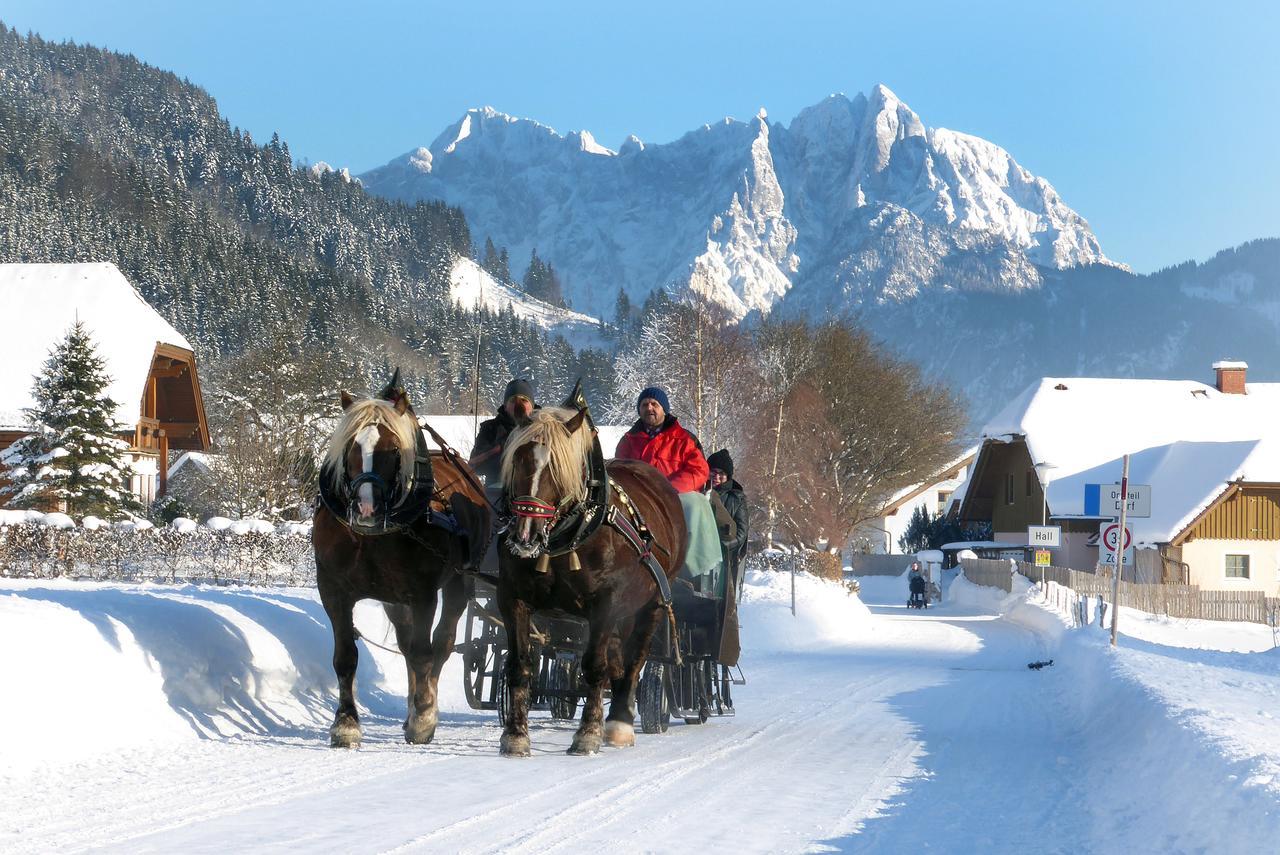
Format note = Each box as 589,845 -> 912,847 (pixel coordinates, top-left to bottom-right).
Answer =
982,378 -> 1280,544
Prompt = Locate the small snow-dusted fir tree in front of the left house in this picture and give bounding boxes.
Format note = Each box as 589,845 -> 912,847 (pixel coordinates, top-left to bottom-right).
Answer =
0,323 -> 141,518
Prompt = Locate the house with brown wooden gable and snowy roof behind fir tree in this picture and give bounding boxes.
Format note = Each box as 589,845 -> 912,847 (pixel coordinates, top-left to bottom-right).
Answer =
0,262 -> 210,502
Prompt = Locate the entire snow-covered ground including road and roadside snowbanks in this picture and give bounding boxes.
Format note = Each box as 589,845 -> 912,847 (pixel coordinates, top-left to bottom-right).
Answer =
0,563 -> 1280,852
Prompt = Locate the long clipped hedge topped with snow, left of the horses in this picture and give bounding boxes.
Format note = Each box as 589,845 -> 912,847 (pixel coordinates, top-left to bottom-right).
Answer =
0,511 -> 315,585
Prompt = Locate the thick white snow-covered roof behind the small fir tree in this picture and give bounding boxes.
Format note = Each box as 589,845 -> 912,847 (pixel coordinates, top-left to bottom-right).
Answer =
0,262 -> 192,430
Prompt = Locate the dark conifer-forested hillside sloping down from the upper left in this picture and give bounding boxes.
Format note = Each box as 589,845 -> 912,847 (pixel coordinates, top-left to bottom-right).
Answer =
0,26 -> 608,407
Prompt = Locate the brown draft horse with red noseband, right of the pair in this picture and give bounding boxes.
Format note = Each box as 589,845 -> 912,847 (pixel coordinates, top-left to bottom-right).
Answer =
498,407 -> 687,756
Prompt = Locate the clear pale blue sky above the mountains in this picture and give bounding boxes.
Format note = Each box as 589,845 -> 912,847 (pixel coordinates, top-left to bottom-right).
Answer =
0,0 -> 1280,271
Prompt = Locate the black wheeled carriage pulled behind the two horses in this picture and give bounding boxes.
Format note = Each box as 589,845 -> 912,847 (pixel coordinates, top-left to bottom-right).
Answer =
457,564 -> 746,733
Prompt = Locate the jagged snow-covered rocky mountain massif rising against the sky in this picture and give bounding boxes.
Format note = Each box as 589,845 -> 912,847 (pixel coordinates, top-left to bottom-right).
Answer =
362,83 -> 1110,317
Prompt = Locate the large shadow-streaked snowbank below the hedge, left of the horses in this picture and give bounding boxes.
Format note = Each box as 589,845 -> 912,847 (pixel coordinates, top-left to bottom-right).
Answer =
0,579 -> 409,782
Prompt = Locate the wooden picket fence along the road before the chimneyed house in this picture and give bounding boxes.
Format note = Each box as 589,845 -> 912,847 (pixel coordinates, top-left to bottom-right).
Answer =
961,558 -> 1280,625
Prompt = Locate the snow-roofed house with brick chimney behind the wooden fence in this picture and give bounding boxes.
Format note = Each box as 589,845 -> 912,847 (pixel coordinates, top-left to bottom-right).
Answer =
957,362 -> 1280,596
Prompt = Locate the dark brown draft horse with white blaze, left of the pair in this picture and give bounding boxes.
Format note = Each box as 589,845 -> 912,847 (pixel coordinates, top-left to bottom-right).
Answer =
311,392 -> 488,747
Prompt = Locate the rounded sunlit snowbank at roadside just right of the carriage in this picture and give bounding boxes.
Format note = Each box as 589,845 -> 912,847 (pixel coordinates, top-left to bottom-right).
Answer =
739,570 -> 872,653
